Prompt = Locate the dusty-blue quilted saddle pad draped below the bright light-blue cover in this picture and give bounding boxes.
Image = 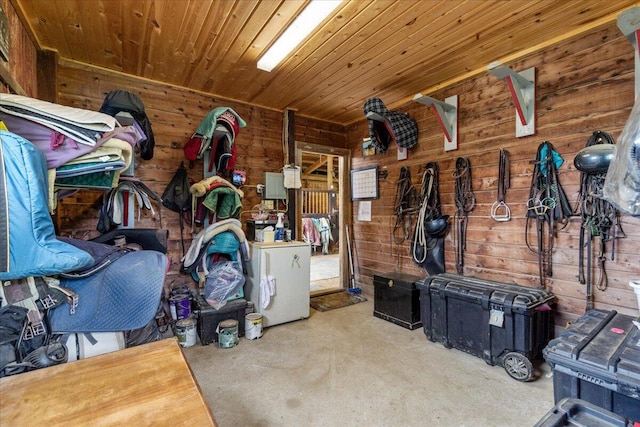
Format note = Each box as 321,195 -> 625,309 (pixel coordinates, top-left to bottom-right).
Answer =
50,250 -> 168,333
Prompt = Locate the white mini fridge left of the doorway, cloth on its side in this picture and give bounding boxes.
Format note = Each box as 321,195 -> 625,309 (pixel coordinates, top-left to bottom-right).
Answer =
244,241 -> 311,327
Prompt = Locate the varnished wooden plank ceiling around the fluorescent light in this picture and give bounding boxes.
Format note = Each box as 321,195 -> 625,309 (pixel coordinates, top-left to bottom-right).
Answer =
11,0 -> 636,124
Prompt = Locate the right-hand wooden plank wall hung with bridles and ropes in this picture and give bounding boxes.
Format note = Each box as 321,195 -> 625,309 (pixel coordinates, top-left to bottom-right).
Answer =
347,24 -> 640,332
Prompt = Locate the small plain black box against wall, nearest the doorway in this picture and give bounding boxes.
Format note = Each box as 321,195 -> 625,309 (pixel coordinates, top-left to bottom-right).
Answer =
373,272 -> 422,330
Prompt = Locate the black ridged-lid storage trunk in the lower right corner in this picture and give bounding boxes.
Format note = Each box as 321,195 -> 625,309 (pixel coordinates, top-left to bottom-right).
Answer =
544,310 -> 640,422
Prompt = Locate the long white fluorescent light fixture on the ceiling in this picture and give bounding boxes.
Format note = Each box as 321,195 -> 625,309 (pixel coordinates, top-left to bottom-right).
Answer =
258,0 -> 342,71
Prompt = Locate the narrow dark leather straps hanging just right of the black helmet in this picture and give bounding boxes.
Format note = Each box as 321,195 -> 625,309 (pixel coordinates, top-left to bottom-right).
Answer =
453,157 -> 476,274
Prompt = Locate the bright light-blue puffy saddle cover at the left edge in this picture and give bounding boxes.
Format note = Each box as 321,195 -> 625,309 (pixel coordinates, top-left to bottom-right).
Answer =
0,131 -> 93,280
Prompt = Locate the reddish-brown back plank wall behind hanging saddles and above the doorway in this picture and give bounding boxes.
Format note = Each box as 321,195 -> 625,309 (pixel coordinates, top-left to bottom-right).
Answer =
56,60 -> 345,290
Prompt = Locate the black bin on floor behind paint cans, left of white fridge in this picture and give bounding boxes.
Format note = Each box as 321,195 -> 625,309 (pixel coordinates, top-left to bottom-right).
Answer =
191,295 -> 247,345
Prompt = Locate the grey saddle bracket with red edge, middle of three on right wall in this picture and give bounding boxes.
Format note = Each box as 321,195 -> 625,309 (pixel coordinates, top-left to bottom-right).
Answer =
487,61 -> 536,137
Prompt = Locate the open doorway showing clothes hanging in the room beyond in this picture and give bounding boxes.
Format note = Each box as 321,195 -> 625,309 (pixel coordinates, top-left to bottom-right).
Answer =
296,142 -> 351,296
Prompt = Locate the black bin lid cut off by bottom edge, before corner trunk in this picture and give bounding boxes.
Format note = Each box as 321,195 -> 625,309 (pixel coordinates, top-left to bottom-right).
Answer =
534,397 -> 633,427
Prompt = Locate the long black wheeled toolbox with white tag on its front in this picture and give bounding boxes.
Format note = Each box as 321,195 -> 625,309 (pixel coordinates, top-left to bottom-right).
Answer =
417,273 -> 555,381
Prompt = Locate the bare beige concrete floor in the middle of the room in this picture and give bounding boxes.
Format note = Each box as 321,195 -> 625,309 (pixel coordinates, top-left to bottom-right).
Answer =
184,296 -> 554,427
